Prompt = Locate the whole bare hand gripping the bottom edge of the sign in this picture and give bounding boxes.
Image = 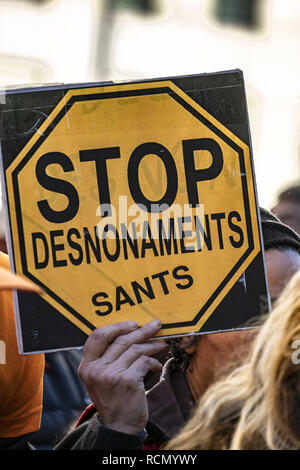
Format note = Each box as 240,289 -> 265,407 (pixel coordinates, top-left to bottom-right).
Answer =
79,320 -> 165,434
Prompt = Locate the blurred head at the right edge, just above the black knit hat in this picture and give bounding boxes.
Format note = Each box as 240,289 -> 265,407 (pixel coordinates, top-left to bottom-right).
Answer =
272,184 -> 300,234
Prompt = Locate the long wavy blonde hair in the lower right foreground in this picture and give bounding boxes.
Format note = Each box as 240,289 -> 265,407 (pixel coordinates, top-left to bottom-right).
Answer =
165,272 -> 300,450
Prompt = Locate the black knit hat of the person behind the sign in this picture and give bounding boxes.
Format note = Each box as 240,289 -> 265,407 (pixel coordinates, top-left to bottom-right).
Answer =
260,208 -> 300,254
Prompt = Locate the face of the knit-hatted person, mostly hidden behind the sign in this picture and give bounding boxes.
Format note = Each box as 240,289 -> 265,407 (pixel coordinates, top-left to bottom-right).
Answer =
186,249 -> 300,398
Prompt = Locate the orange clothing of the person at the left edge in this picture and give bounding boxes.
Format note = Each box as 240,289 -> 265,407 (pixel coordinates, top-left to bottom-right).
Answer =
0,282 -> 45,449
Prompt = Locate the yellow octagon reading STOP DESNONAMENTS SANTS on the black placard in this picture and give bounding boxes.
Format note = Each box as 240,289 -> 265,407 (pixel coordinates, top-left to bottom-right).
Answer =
6,80 -> 261,336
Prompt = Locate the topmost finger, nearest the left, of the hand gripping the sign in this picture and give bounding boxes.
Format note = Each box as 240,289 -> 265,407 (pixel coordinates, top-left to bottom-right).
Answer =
82,322 -> 138,362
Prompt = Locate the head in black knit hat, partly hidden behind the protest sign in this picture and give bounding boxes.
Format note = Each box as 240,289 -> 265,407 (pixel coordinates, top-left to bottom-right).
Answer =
170,208 -> 300,395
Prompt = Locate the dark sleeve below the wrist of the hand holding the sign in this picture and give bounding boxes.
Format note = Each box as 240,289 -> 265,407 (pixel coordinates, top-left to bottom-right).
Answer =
54,413 -> 147,450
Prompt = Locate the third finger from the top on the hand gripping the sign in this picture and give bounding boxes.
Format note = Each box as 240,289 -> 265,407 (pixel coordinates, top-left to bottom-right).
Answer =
109,340 -> 166,370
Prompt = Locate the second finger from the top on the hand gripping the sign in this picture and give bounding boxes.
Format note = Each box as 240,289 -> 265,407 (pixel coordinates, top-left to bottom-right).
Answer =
102,320 -> 161,364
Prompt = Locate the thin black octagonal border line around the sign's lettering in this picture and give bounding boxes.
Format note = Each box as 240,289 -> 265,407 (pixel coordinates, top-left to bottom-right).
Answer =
6,86 -> 254,330
